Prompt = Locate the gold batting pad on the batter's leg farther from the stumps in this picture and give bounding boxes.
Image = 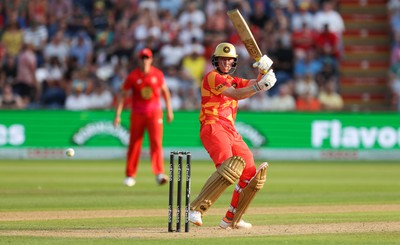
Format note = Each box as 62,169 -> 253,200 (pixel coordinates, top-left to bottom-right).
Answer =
232,162 -> 268,228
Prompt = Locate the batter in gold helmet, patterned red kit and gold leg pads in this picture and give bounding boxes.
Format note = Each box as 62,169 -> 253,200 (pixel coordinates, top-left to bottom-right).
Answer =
189,42 -> 276,229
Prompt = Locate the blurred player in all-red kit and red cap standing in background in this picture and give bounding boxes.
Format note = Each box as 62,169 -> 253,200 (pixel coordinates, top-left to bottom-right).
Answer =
114,48 -> 174,186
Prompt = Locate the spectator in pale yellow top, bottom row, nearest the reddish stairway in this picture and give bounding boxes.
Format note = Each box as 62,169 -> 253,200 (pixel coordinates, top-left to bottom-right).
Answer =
318,80 -> 344,111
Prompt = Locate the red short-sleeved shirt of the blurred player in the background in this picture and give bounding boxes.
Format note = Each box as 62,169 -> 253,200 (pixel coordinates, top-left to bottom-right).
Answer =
122,66 -> 165,113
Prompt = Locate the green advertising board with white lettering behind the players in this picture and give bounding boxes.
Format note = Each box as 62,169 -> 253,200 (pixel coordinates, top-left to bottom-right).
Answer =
0,110 -> 400,160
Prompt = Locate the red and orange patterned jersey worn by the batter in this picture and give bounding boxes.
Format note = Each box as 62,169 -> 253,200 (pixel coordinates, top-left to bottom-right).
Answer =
199,70 -> 249,127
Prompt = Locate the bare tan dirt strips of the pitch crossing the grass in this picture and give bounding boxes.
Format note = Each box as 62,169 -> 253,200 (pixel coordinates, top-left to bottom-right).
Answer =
0,205 -> 400,239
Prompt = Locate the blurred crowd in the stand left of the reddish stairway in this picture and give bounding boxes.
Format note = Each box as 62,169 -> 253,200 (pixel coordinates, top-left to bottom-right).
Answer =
0,0 -> 344,111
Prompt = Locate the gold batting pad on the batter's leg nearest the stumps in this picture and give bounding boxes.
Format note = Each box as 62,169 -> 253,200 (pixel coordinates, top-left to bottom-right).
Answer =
190,156 -> 245,214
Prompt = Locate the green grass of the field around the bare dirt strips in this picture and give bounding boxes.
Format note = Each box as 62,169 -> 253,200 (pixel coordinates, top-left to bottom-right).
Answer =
0,160 -> 400,245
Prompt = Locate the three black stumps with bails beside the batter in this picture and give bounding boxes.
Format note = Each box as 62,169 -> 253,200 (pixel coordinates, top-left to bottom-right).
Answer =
168,151 -> 191,232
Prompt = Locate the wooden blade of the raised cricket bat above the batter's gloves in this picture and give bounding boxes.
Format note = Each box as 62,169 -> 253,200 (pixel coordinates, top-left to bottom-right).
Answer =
227,9 -> 262,61
